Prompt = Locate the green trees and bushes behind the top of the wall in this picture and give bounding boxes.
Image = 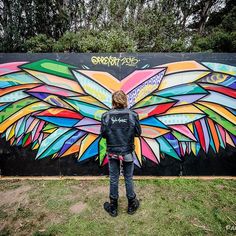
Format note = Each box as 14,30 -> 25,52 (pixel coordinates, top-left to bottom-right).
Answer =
0,0 -> 236,52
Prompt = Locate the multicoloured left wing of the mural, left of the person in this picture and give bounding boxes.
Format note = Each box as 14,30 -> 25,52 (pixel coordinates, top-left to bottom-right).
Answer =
0,60 -> 111,161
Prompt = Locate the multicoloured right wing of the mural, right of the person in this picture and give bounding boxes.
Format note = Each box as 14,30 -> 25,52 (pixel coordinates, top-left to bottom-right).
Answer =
128,61 -> 236,167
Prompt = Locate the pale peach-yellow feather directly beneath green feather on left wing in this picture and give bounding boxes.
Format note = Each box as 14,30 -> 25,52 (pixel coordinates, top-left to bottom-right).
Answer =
25,69 -> 84,94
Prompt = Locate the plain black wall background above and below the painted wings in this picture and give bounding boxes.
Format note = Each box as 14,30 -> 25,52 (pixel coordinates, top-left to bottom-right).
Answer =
0,53 -> 236,176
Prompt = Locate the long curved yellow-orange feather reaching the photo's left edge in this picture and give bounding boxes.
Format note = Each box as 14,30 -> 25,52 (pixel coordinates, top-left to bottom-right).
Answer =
0,102 -> 48,133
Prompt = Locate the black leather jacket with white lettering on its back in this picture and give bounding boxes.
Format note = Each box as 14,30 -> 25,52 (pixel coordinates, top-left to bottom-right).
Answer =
101,108 -> 141,155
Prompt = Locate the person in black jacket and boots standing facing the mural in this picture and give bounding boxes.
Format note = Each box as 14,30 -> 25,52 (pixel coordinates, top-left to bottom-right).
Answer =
101,90 -> 141,216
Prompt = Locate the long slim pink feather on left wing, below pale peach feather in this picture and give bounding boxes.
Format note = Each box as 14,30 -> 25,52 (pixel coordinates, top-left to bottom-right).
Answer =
28,83 -> 80,97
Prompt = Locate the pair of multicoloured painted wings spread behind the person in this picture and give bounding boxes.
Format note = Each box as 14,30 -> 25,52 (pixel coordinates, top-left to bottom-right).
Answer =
0,59 -> 236,171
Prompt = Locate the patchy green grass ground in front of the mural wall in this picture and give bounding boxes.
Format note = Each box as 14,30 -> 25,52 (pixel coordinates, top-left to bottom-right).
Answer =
0,179 -> 236,236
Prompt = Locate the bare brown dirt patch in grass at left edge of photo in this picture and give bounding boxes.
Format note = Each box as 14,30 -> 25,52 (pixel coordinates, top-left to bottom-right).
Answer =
0,185 -> 32,206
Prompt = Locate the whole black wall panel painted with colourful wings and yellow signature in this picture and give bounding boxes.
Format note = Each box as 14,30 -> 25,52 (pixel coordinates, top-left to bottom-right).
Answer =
0,54 -> 236,175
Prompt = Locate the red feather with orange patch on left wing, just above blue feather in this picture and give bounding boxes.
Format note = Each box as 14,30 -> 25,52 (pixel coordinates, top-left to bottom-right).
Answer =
36,108 -> 83,119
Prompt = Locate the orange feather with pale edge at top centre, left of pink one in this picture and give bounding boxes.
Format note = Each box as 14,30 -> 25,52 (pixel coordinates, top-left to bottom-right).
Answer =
78,70 -> 122,92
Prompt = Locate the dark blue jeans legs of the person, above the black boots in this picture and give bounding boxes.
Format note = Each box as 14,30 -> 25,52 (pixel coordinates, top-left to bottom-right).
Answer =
109,159 -> 136,199
